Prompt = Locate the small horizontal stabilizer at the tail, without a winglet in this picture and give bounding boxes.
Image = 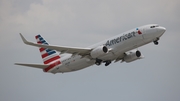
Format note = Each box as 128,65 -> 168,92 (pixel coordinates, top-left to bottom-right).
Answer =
15,63 -> 49,69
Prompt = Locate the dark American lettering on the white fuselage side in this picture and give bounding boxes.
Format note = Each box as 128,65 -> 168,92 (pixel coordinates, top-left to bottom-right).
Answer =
105,31 -> 137,46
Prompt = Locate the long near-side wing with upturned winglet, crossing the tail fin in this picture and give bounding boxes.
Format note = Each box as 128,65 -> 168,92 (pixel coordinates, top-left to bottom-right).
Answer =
20,33 -> 92,56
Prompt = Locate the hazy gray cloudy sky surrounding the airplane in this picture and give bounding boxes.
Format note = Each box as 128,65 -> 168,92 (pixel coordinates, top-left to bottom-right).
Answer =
0,0 -> 180,101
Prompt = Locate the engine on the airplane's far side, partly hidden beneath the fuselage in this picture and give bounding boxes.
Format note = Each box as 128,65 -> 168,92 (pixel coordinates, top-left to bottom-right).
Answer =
124,50 -> 143,63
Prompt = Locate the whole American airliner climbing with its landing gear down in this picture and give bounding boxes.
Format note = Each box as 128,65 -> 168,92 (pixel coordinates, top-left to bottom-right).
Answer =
15,24 -> 166,74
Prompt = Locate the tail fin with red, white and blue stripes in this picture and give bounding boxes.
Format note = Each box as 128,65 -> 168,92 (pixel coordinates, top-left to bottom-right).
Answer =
35,35 -> 61,64
